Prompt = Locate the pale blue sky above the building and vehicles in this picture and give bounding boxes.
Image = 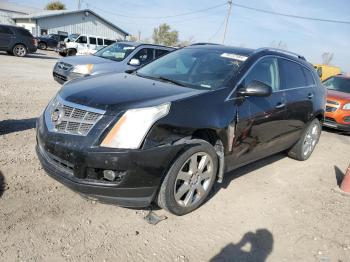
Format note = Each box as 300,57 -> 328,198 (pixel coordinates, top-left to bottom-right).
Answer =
9,0 -> 350,72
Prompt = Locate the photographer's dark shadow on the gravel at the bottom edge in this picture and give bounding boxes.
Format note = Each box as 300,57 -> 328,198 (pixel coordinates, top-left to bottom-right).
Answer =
210,229 -> 273,262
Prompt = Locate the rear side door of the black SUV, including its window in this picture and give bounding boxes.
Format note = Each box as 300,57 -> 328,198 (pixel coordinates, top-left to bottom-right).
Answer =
279,58 -> 315,144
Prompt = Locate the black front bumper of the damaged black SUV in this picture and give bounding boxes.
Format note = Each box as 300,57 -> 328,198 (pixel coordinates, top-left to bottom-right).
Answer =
36,115 -> 189,208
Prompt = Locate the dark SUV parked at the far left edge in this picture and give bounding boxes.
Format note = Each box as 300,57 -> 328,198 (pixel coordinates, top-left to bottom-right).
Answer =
0,24 -> 37,57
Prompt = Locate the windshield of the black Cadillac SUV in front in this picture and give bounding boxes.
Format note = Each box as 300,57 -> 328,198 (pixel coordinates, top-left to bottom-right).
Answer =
137,48 -> 247,89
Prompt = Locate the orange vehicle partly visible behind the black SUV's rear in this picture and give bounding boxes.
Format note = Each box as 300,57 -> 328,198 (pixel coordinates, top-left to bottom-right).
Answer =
323,75 -> 350,132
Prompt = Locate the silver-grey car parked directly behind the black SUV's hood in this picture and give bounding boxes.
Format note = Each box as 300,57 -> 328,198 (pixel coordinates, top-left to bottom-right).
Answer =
53,42 -> 175,84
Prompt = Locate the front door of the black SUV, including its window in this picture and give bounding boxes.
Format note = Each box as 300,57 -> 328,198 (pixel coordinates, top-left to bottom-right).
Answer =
226,57 -> 286,169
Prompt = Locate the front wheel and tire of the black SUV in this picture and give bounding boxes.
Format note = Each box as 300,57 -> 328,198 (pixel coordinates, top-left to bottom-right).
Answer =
158,139 -> 218,216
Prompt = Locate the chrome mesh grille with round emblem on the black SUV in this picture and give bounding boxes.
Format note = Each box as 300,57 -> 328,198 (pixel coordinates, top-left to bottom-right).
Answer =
45,98 -> 104,136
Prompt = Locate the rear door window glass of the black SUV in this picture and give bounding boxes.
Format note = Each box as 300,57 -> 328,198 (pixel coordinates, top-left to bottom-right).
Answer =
280,59 -> 307,89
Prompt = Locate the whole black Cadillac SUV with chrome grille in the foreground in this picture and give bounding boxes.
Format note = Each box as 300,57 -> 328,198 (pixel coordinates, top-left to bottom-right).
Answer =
37,45 -> 326,215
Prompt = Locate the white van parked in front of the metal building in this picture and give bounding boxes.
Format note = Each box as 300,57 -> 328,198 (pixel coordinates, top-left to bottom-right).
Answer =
56,34 -> 116,56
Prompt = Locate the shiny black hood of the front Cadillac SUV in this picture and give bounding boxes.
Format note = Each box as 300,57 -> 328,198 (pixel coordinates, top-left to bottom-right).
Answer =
59,73 -> 208,115
